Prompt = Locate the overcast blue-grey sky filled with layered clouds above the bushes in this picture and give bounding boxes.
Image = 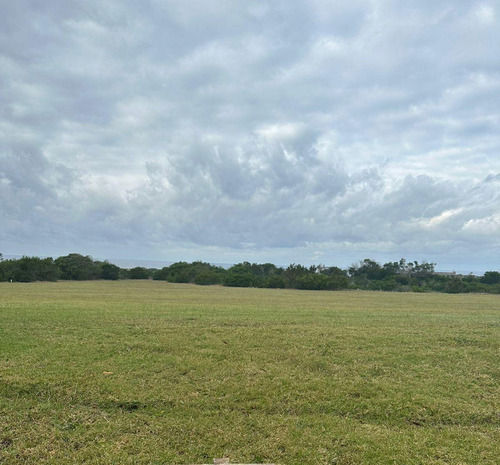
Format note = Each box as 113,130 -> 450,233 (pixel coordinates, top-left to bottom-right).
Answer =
0,0 -> 500,273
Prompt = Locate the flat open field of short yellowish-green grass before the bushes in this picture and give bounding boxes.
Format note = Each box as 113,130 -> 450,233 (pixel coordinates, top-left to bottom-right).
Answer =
0,281 -> 500,465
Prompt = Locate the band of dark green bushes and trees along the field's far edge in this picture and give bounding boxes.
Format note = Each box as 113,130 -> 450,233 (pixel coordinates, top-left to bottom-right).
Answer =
0,253 -> 500,294
